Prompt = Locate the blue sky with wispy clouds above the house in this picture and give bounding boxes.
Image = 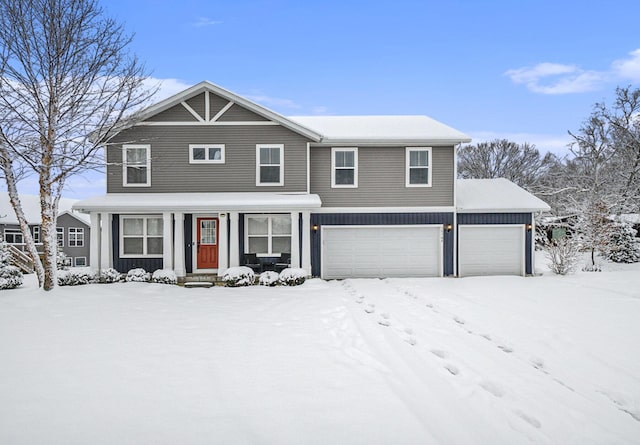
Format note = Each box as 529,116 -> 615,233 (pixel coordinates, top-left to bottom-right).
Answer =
6,0 -> 640,196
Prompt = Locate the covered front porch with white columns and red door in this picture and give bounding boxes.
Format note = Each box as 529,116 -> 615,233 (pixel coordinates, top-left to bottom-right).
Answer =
74,193 -> 321,278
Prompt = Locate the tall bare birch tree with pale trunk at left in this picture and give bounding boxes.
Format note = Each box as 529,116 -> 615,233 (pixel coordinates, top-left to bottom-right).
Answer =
0,0 -> 151,290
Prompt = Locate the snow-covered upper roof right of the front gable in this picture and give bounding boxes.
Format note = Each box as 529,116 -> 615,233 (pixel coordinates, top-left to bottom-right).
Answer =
289,116 -> 471,144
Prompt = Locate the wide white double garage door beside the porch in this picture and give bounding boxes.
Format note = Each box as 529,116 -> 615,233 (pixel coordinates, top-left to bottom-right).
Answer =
321,225 -> 442,279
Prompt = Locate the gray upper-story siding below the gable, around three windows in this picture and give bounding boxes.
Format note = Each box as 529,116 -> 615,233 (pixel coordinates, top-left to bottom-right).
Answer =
107,125 -> 307,193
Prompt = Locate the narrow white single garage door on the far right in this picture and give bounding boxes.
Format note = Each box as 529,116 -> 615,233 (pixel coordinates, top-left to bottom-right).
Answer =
458,224 -> 525,277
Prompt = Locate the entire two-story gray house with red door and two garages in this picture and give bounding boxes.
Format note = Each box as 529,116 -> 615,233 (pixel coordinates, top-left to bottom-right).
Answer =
74,82 -> 548,278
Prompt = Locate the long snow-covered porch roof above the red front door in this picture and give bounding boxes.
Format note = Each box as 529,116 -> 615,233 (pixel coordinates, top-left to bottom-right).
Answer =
73,192 -> 321,213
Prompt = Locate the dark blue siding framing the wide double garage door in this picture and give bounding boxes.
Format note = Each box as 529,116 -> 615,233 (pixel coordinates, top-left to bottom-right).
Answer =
311,213 -> 454,277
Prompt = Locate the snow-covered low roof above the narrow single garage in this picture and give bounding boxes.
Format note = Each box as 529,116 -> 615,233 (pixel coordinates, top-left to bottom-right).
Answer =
456,178 -> 550,213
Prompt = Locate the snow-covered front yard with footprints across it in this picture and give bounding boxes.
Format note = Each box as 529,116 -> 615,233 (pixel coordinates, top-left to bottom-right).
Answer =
0,255 -> 640,445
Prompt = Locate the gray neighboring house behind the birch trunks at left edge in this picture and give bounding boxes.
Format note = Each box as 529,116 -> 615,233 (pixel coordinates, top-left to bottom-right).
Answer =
0,192 -> 91,266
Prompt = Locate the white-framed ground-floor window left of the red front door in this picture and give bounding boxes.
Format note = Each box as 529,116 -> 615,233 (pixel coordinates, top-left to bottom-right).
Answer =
120,215 -> 163,258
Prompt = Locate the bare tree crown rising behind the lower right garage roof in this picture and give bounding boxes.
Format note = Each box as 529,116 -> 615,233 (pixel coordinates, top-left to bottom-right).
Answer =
458,139 -> 554,190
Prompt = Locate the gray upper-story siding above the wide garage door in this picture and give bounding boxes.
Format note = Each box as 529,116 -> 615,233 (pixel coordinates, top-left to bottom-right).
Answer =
311,147 -> 454,207
